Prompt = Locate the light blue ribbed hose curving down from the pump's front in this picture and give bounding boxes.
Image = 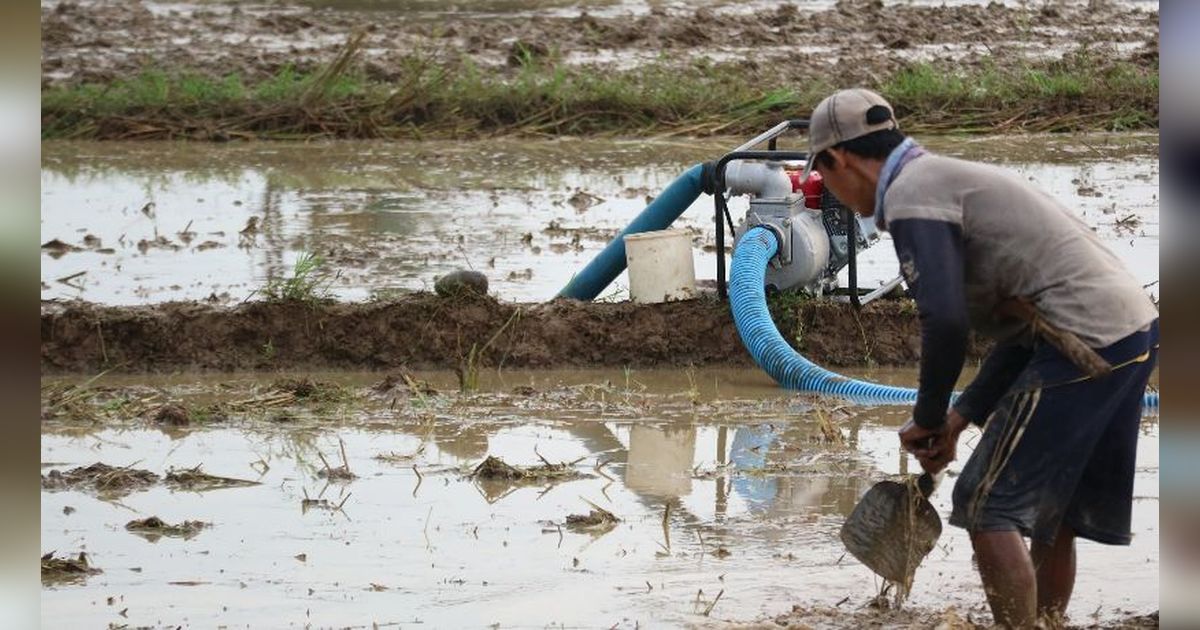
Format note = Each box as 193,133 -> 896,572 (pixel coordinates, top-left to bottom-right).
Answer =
730,227 -> 1158,412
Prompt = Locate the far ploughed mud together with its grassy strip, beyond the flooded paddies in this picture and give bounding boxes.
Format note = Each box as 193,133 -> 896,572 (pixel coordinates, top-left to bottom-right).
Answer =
42,0 -> 1158,142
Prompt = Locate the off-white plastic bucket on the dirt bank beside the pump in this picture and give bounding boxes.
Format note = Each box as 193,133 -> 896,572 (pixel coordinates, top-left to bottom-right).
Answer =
625,229 -> 696,304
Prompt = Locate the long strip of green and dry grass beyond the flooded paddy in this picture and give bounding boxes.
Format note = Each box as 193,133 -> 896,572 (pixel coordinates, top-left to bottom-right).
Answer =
42,52 -> 1158,139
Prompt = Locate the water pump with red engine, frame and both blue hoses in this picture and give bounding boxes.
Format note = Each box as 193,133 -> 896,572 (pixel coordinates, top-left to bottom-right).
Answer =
559,120 -> 1158,409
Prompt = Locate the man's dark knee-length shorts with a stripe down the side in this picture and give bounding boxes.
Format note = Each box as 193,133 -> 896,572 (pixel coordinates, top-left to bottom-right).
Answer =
950,320 -> 1158,545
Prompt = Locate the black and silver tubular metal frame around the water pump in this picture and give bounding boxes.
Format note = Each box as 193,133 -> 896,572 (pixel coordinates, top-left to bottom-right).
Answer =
713,119 -> 863,308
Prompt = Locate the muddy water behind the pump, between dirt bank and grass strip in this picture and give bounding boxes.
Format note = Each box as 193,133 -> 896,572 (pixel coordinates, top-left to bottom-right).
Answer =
41,134 -> 1159,304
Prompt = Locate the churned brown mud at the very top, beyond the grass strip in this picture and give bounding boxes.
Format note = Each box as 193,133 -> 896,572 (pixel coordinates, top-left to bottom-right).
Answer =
42,0 -> 1158,85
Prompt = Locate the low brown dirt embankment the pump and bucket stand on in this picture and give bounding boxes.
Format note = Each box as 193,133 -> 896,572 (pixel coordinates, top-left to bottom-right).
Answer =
41,294 -> 985,373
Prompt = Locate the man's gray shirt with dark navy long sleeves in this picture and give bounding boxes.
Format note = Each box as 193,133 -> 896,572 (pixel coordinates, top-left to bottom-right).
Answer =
876,154 -> 1158,428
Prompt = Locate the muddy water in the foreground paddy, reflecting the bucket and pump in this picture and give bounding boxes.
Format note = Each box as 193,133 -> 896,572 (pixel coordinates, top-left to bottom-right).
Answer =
41,371 -> 1159,628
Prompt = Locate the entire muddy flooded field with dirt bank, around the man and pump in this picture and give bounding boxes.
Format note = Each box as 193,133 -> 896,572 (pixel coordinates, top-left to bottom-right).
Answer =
40,0 -> 1159,629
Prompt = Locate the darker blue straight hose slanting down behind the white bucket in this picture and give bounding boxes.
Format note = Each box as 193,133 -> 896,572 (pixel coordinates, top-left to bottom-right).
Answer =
558,164 -> 703,301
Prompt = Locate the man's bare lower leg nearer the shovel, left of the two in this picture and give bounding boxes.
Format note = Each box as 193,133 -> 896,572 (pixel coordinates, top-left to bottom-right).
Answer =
971,532 -> 1037,628
